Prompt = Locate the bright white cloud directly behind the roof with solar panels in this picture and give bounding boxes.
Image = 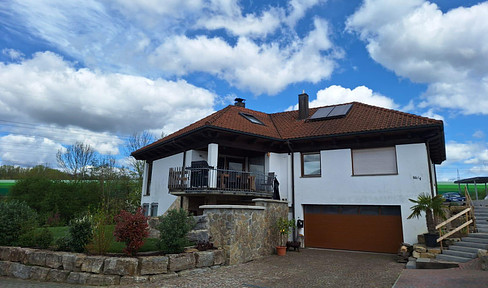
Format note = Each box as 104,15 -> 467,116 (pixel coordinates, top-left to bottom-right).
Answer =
287,85 -> 398,110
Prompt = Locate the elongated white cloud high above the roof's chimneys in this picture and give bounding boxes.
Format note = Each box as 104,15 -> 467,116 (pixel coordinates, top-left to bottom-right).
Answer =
150,19 -> 341,94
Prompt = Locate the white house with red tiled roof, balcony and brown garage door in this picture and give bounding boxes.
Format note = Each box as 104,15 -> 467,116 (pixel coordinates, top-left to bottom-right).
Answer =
132,93 -> 446,252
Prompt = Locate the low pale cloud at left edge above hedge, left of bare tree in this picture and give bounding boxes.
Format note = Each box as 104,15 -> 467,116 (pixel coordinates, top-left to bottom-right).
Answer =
0,134 -> 63,167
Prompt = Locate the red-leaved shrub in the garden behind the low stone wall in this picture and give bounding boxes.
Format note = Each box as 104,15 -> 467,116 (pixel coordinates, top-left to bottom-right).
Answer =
114,207 -> 149,256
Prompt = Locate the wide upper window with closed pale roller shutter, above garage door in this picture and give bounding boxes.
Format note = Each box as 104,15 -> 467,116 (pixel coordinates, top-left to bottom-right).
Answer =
352,147 -> 398,175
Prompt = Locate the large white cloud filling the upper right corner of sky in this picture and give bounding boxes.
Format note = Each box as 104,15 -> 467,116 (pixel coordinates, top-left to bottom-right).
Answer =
346,0 -> 488,114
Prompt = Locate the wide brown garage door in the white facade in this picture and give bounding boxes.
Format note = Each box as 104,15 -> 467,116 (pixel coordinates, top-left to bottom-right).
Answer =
304,205 -> 403,253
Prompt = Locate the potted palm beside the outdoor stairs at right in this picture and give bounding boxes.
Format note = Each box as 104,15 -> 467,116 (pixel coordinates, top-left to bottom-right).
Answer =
407,193 -> 445,247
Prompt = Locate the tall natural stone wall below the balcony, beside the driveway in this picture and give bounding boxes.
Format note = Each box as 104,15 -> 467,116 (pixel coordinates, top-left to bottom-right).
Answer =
200,199 -> 288,265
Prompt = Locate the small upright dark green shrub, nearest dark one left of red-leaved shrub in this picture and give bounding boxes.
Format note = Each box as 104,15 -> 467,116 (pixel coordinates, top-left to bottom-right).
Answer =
68,215 -> 93,252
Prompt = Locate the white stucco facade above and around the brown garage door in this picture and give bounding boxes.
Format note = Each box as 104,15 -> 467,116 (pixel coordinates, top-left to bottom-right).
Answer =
270,143 -> 432,243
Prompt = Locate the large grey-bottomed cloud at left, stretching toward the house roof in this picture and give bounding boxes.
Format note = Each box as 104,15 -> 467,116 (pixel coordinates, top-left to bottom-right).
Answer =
0,52 -> 216,166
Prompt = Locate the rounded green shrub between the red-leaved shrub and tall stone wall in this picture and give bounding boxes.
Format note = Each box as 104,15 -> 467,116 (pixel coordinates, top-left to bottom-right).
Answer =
158,209 -> 195,253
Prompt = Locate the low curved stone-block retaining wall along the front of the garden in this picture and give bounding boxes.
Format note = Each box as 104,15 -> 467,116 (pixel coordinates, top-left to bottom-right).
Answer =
0,246 -> 225,285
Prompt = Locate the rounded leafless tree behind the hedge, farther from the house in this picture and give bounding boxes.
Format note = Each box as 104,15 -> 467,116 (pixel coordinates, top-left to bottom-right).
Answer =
56,142 -> 96,179
